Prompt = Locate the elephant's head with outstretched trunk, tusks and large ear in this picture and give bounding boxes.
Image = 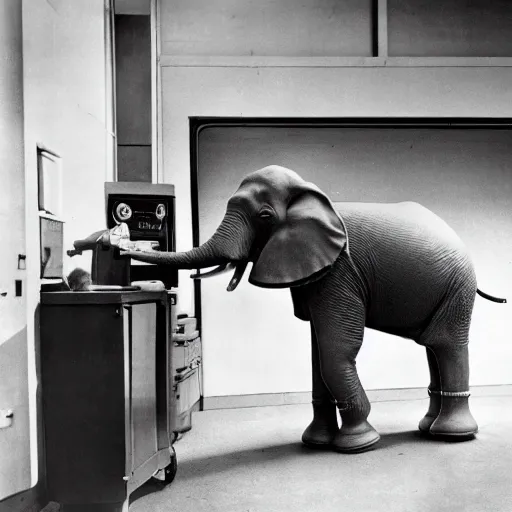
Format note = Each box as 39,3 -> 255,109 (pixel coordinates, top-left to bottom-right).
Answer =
122,165 -> 347,291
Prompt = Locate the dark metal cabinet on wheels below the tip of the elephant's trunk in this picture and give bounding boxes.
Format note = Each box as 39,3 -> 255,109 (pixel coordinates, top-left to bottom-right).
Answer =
40,291 -> 176,512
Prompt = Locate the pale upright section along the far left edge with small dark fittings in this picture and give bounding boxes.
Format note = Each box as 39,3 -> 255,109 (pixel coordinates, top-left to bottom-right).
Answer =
0,0 -> 31,500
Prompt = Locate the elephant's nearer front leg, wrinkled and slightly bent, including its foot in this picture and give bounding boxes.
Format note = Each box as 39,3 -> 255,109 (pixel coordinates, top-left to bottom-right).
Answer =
313,304 -> 380,453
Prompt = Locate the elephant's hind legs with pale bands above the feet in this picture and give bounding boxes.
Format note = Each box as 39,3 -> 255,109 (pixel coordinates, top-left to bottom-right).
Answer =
419,289 -> 478,439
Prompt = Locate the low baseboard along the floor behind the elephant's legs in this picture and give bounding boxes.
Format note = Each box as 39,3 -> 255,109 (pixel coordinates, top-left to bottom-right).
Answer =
202,384 -> 512,411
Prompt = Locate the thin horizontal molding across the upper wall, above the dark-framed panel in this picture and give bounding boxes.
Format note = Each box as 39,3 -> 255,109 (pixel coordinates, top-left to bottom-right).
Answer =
158,55 -> 512,68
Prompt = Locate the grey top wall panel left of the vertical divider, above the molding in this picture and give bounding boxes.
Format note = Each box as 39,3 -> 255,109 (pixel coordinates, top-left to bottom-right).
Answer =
160,0 -> 372,57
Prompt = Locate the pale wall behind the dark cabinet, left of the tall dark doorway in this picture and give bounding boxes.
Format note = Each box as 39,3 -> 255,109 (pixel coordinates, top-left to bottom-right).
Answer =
23,0 -> 113,496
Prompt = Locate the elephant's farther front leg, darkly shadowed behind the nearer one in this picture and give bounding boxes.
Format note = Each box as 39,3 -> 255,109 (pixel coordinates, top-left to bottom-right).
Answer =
302,323 -> 338,448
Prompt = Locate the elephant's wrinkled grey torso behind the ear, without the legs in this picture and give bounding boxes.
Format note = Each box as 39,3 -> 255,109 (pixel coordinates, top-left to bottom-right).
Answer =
335,202 -> 476,334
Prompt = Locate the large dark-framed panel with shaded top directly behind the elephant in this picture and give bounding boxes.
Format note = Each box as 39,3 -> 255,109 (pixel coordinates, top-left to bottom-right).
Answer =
198,127 -> 512,394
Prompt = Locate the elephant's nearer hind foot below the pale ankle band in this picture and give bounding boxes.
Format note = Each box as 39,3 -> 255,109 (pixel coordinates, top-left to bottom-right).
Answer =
429,391 -> 478,440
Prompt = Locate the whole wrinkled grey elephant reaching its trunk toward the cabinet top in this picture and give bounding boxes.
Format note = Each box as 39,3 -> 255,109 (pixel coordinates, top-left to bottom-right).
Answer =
121,165 -> 506,453
